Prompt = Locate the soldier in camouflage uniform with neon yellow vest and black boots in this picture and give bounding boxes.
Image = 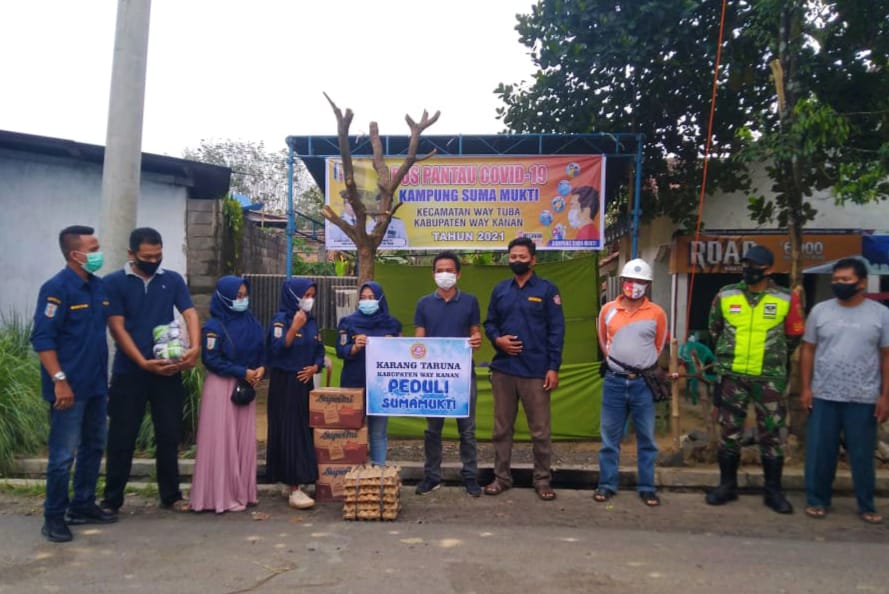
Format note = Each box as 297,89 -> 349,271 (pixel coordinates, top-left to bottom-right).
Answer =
707,245 -> 803,514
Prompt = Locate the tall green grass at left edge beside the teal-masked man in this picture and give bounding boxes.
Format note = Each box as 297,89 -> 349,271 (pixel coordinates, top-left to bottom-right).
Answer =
0,315 -> 49,474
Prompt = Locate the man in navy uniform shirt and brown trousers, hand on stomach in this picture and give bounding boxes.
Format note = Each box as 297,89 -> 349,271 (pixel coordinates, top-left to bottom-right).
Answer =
485,237 -> 565,501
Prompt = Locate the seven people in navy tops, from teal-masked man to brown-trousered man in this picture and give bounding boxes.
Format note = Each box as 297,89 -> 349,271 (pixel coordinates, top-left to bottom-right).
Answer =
32,226 -> 564,542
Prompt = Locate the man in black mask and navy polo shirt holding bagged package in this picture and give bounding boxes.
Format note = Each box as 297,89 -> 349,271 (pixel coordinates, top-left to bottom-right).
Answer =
102,227 -> 201,511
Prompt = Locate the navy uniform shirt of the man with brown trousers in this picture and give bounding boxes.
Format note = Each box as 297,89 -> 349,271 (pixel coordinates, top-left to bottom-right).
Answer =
484,274 -> 565,378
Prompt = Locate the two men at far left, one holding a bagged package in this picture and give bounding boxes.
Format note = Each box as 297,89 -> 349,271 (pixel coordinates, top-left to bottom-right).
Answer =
31,226 -> 201,542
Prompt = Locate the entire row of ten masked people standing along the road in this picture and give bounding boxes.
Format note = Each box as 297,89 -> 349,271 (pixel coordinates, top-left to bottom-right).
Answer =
32,226 -> 889,542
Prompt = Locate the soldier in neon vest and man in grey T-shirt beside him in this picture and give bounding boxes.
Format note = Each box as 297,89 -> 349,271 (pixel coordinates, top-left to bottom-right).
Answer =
707,246 -> 889,524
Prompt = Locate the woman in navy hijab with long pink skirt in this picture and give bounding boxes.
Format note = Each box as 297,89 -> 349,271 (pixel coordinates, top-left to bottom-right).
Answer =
190,276 -> 265,513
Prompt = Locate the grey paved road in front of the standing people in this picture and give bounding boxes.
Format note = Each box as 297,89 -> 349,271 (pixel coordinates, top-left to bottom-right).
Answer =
0,487 -> 889,594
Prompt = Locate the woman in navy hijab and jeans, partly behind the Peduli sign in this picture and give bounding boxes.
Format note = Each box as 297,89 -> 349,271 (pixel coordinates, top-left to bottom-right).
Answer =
336,281 -> 401,466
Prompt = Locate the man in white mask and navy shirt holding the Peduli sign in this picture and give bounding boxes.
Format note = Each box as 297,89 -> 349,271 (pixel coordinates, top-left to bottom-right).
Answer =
414,252 -> 482,497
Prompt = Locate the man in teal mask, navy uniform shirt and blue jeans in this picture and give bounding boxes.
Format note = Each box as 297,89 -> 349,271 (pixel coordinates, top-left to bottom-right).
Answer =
31,225 -> 117,542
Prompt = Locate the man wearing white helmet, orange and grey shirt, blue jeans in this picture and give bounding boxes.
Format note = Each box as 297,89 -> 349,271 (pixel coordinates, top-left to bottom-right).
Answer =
593,258 -> 667,507
